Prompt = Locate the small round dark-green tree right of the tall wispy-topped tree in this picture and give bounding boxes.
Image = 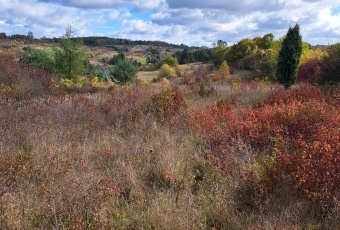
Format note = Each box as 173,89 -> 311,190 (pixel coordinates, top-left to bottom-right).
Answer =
113,59 -> 138,83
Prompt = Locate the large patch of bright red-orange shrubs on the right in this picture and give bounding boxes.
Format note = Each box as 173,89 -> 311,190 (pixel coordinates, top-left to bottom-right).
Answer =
182,85 -> 340,207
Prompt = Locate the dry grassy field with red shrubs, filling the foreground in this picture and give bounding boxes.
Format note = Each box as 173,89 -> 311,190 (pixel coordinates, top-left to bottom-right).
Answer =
0,42 -> 340,229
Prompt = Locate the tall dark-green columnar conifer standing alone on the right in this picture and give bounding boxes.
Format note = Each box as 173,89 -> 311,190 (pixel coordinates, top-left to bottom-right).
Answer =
276,24 -> 302,89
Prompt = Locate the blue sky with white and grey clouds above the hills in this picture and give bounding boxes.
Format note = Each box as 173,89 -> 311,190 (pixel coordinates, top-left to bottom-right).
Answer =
0,0 -> 340,47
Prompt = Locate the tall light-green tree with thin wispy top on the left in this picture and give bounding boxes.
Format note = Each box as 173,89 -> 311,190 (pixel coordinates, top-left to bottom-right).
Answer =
55,25 -> 85,79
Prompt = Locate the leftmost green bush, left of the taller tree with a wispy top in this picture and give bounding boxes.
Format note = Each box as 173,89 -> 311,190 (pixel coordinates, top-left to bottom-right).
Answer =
19,46 -> 54,73
